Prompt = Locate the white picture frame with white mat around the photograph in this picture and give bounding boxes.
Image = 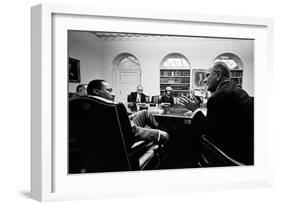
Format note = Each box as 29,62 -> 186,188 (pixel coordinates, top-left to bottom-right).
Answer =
31,4 -> 273,201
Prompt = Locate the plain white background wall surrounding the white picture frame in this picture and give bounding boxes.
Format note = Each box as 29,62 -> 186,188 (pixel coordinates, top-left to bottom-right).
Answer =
0,0 -> 281,206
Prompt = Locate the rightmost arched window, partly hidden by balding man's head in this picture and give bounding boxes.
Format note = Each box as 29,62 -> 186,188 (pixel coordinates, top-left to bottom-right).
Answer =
214,53 -> 244,87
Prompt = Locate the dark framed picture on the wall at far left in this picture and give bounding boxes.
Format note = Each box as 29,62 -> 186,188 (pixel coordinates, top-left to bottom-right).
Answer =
68,57 -> 81,83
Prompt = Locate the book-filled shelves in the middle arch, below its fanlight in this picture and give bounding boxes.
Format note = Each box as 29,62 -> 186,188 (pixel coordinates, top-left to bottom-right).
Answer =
160,69 -> 190,96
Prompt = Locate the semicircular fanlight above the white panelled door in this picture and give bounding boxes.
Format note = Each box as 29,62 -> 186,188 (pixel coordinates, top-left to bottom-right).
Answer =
114,53 -> 140,69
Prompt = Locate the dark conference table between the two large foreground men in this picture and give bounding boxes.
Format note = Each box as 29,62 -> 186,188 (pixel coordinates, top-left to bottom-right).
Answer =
126,104 -> 206,169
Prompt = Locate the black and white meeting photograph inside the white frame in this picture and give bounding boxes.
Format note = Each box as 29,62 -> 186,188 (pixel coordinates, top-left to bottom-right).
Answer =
67,30 -> 255,174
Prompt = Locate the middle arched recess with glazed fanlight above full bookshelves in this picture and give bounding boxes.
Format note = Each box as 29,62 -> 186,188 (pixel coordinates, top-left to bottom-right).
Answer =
160,53 -> 190,96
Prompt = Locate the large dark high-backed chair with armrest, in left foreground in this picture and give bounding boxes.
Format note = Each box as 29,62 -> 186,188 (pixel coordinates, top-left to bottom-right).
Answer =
69,97 -> 160,173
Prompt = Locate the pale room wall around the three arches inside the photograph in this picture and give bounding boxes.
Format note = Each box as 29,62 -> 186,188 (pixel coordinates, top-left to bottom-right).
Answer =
68,31 -> 254,96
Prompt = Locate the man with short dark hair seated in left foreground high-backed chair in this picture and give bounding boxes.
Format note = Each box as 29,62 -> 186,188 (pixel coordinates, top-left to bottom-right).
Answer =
87,79 -> 169,143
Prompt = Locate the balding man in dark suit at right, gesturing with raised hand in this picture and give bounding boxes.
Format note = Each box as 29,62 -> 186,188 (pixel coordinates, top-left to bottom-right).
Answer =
179,62 -> 254,165
